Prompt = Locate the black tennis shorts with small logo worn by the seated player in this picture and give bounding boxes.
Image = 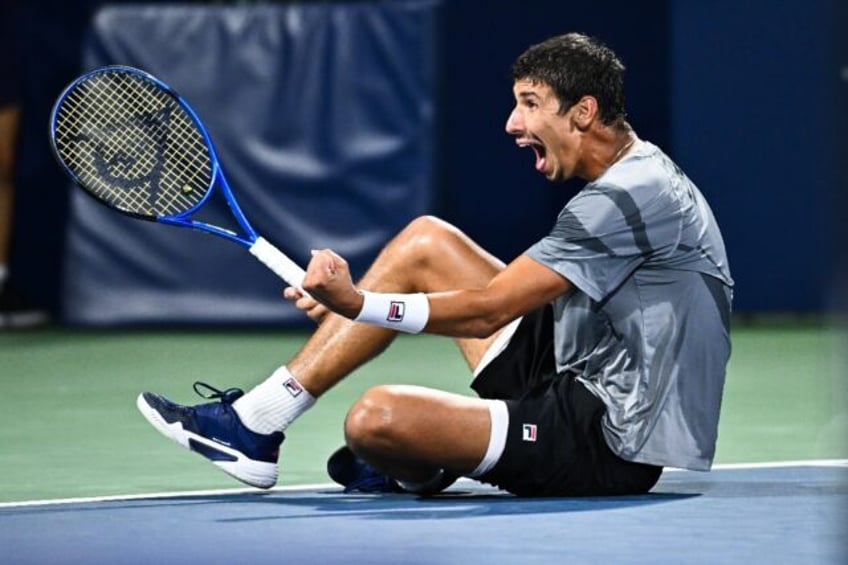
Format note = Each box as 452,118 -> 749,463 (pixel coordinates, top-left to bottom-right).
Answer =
471,306 -> 662,496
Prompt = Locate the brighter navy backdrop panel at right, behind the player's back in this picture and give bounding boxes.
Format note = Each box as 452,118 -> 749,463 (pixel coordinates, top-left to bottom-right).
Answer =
670,0 -> 848,311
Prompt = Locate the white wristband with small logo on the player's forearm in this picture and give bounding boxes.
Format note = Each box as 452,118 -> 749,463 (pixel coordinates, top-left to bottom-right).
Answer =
354,290 -> 430,334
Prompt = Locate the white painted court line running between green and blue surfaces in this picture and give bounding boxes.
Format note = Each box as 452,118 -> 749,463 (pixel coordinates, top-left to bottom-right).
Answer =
0,459 -> 848,509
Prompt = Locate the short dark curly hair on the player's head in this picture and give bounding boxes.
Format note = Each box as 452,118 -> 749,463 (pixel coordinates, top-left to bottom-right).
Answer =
510,33 -> 627,125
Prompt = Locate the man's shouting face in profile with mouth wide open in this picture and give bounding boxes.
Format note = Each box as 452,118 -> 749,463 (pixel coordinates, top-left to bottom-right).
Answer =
506,79 -> 580,181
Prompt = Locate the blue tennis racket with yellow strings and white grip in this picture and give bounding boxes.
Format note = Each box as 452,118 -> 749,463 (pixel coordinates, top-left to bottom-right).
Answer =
50,65 -> 305,288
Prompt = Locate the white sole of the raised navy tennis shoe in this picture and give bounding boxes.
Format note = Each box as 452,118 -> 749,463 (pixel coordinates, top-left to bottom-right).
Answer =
136,394 -> 279,489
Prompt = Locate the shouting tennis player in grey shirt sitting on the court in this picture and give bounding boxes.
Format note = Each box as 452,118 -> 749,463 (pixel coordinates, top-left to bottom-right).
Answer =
138,33 -> 733,496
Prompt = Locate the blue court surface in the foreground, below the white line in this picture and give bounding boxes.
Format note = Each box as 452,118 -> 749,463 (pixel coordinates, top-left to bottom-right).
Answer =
0,462 -> 848,564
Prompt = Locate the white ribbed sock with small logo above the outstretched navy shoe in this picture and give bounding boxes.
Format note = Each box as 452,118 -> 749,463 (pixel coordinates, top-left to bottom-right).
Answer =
233,365 -> 315,434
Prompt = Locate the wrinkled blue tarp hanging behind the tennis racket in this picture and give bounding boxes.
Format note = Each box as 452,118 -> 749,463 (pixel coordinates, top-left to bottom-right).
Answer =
63,0 -> 439,325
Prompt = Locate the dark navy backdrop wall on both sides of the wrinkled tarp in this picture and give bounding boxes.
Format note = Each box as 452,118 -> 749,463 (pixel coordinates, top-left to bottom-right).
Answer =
12,0 -> 848,321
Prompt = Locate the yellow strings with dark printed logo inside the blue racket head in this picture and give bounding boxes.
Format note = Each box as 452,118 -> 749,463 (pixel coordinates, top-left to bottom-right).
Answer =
56,70 -> 213,217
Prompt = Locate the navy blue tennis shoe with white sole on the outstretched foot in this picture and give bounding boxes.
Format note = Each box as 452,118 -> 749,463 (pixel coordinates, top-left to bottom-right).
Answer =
136,382 -> 285,488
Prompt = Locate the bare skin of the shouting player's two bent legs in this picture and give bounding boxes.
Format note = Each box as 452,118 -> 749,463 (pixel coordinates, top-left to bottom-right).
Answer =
287,217 -> 504,481
